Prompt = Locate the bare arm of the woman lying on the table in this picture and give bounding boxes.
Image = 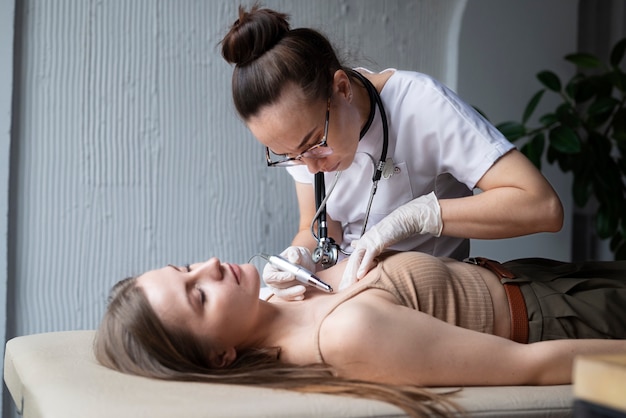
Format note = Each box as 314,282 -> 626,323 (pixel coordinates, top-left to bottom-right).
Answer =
320,292 -> 626,386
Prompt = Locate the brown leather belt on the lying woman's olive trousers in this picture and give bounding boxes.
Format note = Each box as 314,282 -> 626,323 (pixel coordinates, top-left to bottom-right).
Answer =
465,257 -> 528,344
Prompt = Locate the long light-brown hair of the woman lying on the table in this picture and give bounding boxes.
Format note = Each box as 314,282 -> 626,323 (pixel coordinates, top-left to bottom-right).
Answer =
94,277 -> 458,417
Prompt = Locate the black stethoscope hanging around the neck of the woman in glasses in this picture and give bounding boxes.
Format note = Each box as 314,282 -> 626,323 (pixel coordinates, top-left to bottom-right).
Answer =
311,69 -> 393,268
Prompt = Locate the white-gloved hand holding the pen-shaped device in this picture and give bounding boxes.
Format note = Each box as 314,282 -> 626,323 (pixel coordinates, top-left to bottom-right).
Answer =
263,246 -> 315,301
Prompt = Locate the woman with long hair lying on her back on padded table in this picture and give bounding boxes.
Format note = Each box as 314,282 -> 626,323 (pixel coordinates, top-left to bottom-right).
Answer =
95,252 -> 626,416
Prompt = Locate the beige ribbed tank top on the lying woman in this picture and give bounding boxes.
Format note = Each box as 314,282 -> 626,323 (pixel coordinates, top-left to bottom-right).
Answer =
315,252 -> 494,362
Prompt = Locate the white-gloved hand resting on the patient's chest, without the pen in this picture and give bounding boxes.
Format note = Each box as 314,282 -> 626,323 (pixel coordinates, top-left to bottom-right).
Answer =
339,192 -> 443,290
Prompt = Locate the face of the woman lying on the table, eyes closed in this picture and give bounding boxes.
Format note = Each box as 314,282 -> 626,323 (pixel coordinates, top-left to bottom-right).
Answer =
137,258 -> 261,346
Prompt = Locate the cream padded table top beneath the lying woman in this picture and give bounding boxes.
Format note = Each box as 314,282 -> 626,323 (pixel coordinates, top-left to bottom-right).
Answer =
4,331 -> 573,418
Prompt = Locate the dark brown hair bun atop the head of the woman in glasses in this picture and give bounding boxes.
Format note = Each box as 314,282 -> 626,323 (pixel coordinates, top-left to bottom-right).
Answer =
221,5 -> 289,65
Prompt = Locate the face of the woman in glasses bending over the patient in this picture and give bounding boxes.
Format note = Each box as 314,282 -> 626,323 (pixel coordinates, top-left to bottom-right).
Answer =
247,81 -> 360,173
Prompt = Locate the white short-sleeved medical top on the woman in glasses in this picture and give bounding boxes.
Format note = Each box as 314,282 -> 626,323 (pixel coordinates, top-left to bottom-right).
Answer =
287,69 -> 514,259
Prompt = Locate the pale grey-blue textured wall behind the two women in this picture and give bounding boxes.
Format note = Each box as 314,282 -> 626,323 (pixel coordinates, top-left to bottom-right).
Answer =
9,0 -> 464,335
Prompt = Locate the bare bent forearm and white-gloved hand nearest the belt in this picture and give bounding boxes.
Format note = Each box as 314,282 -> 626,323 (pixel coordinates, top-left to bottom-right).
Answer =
339,150 -> 563,289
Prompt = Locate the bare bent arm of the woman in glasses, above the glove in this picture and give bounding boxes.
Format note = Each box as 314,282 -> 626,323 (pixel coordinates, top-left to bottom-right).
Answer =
439,150 -> 563,239
